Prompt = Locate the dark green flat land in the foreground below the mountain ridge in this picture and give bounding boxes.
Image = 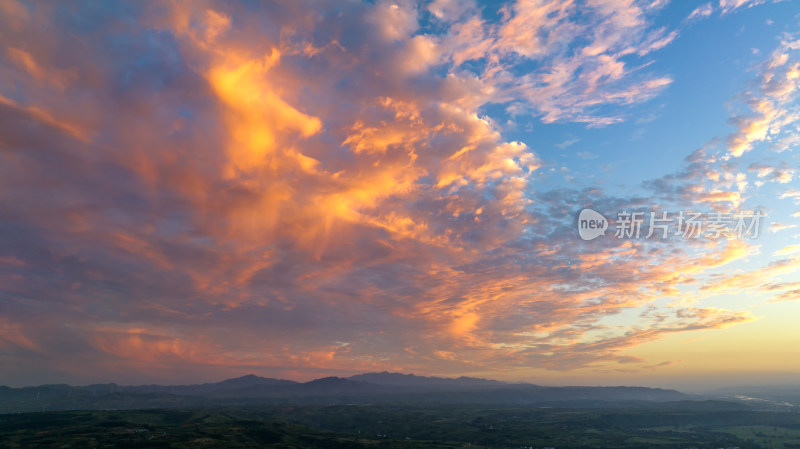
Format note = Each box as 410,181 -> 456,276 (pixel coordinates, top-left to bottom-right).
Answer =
0,405 -> 800,449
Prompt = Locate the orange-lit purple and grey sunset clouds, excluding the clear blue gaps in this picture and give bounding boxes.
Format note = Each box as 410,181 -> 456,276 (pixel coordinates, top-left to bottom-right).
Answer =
0,0 -> 798,381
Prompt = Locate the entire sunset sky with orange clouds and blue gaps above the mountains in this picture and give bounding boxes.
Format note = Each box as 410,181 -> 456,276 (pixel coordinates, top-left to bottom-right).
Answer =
0,0 -> 800,390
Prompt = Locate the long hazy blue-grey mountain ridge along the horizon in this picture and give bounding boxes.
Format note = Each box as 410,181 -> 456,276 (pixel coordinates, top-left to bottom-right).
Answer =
0,372 -> 691,413
